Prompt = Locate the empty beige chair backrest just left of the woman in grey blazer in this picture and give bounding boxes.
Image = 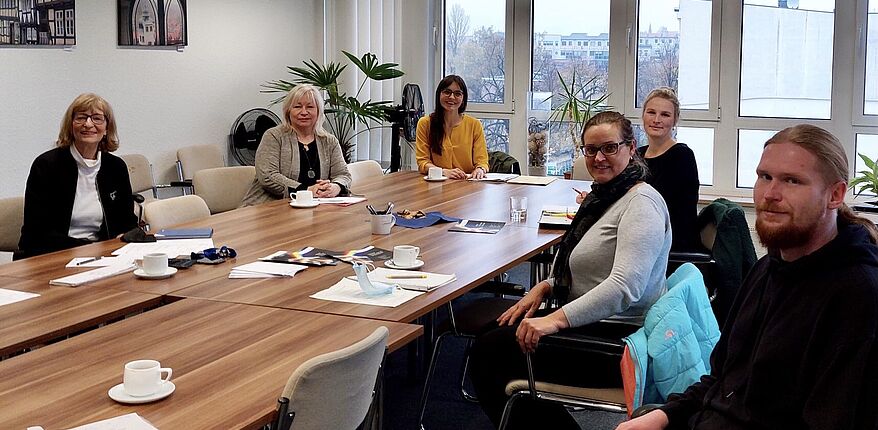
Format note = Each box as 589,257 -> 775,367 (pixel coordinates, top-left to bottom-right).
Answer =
192,166 -> 256,214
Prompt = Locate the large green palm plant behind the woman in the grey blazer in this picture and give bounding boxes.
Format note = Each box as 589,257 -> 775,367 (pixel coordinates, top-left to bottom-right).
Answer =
262,51 -> 405,162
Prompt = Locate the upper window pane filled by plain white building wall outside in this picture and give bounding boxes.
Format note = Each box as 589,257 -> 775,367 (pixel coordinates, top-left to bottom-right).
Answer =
739,0 -> 835,119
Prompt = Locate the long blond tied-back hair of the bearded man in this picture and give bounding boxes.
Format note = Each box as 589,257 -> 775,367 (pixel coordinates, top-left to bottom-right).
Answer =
763,124 -> 878,243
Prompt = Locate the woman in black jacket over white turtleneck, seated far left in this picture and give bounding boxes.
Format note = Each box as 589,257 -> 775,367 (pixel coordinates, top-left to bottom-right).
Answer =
16,94 -> 137,258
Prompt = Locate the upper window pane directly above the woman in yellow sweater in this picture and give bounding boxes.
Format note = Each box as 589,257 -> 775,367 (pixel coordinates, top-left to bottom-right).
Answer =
444,0 -> 506,104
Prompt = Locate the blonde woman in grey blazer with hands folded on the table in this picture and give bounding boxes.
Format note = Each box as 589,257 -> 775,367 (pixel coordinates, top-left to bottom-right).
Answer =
241,84 -> 351,206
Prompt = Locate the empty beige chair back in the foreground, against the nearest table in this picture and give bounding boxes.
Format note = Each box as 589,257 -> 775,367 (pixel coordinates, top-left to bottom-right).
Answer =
272,327 -> 389,430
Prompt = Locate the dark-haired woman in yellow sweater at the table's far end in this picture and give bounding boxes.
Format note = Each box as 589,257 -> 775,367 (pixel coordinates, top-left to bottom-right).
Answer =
416,75 -> 488,179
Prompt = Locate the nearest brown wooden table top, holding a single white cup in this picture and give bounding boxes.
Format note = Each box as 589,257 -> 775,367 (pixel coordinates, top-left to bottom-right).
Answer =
0,299 -> 422,430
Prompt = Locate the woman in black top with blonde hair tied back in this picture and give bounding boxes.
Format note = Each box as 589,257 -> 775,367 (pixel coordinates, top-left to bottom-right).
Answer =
638,87 -> 703,252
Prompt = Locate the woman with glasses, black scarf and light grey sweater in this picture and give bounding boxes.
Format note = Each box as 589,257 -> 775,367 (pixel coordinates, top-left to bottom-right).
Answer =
471,112 -> 671,429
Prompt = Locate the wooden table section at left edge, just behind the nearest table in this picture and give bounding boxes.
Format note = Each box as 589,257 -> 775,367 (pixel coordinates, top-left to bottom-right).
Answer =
0,277 -> 162,357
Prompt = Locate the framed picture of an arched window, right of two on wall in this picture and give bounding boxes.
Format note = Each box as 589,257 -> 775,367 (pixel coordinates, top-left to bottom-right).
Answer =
117,0 -> 188,46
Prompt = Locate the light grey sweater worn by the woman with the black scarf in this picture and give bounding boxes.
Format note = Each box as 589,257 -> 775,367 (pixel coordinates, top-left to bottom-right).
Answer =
548,183 -> 671,327
